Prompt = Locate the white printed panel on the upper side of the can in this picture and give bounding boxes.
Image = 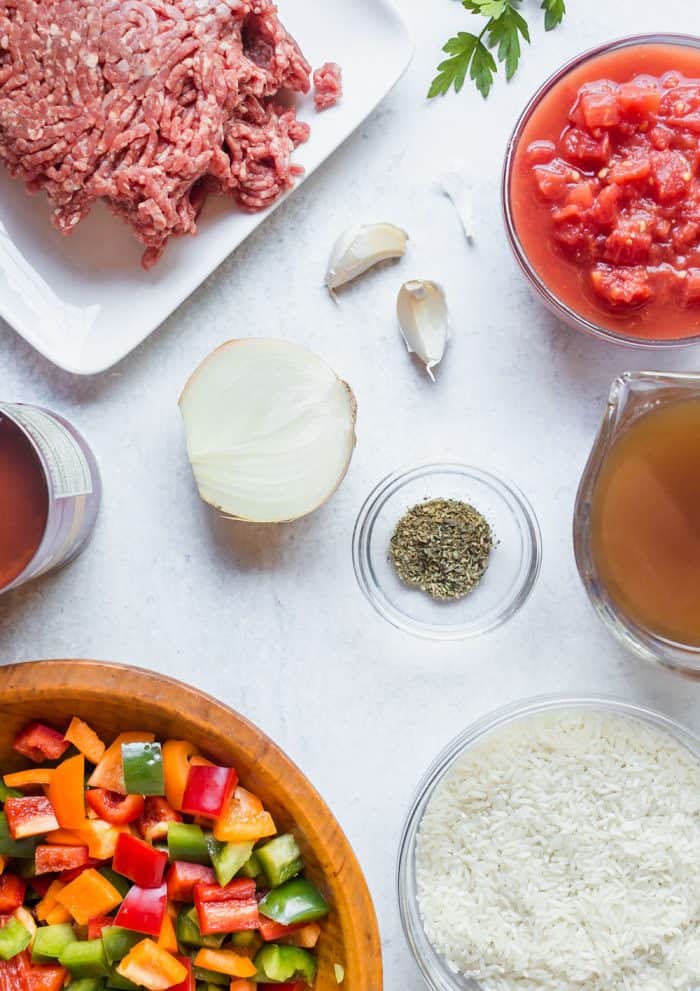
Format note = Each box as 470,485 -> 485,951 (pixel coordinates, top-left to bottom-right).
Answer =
0,403 -> 92,499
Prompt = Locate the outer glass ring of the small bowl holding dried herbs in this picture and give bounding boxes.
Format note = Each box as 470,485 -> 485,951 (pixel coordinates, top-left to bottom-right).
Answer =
352,459 -> 542,641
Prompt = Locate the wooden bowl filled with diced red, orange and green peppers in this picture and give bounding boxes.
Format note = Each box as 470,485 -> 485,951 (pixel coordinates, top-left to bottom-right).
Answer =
0,661 -> 381,991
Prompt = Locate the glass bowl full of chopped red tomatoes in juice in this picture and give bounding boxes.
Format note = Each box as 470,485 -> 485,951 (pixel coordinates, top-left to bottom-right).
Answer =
502,34 -> 700,348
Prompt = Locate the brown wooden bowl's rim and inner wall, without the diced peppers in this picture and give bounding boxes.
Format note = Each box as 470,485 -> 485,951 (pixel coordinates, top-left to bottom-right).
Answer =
0,660 -> 382,991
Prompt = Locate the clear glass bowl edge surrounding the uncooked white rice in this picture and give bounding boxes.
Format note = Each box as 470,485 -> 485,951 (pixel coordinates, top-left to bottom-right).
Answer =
397,696 -> 700,991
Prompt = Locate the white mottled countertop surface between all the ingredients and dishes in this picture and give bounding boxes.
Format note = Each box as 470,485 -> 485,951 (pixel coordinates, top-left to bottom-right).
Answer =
0,0 -> 700,991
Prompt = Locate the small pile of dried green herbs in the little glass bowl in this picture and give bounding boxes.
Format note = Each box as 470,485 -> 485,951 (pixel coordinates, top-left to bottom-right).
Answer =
390,499 -> 493,599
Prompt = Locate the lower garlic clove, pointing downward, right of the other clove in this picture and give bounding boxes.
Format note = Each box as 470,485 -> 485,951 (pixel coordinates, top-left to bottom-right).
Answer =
396,279 -> 449,382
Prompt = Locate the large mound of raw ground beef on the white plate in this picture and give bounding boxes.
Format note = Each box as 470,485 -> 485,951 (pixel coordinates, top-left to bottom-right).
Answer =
0,0 -> 330,268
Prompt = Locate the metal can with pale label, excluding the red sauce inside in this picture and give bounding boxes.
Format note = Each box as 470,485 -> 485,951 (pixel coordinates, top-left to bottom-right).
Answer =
0,402 -> 102,594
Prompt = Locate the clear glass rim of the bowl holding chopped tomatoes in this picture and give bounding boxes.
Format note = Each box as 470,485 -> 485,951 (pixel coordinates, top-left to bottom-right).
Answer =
501,33 -> 700,350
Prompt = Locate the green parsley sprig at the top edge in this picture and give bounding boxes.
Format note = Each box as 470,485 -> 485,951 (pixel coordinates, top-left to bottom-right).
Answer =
428,0 -> 566,98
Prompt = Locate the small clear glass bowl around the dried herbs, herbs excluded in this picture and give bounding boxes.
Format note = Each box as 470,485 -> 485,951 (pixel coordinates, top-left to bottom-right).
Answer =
352,462 -> 542,640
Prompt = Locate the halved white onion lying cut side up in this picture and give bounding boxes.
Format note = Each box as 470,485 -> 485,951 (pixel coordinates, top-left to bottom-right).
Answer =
180,338 -> 356,523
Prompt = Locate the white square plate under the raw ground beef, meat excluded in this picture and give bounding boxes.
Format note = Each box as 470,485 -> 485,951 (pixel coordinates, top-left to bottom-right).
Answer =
0,0 -> 412,375
